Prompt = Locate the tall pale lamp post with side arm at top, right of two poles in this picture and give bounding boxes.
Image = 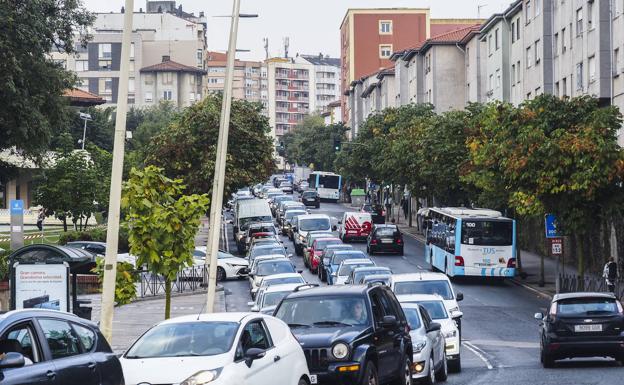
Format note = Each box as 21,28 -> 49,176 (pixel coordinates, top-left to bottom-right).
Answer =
205,0 -> 258,313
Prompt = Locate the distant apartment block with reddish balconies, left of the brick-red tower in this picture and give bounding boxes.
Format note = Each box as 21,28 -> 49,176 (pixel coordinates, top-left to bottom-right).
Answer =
265,58 -> 316,138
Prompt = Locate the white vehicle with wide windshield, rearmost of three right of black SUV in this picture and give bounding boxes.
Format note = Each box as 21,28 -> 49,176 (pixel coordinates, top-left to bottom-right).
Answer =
391,271 -> 464,333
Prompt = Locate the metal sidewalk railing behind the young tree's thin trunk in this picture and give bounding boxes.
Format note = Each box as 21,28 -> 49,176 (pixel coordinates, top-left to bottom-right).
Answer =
138,265 -> 208,297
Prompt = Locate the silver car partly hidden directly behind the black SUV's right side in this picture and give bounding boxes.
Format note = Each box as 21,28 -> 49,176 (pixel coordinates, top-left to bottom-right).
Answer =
401,303 -> 448,385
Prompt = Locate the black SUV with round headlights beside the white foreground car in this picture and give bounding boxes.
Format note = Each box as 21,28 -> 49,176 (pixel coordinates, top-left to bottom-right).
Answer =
274,284 -> 412,385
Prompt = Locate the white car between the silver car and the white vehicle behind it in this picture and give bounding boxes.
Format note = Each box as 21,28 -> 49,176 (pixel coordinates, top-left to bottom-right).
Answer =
396,294 -> 461,372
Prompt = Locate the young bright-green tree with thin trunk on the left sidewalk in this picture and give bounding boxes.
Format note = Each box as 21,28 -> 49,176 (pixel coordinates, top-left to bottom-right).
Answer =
121,166 -> 209,319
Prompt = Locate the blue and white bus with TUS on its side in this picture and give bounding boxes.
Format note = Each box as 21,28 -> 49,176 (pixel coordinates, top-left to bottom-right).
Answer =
424,207 -> 516,277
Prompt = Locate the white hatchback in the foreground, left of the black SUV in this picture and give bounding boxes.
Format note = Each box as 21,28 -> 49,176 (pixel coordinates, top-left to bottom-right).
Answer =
119,313 -> 310,385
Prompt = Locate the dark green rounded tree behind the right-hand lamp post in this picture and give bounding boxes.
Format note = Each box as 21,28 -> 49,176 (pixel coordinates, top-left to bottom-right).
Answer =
146,95 -> 274,200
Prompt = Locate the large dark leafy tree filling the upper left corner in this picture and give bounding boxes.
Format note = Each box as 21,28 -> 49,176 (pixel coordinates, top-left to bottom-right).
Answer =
0,0 -> 95,153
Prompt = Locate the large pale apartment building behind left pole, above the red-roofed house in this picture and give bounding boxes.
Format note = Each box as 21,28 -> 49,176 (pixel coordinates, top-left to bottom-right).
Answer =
51,1 -> 206,106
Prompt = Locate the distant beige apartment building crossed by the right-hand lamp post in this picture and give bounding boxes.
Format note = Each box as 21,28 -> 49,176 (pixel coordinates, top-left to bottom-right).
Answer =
206,51 -> 268,108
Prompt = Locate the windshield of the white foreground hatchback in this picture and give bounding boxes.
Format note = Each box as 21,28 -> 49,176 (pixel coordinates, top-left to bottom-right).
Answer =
125,322 -> 238,359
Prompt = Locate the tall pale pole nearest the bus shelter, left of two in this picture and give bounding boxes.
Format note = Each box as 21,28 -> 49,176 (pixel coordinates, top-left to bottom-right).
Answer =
100,0 -> 134,343
